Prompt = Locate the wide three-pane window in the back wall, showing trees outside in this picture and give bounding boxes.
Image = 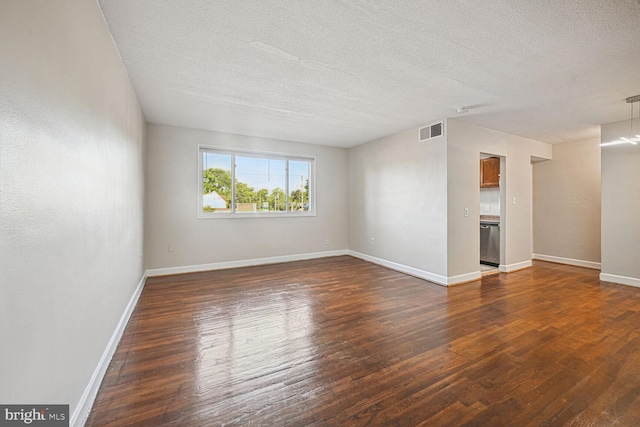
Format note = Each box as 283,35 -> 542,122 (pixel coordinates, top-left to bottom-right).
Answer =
198,147 -> 315,218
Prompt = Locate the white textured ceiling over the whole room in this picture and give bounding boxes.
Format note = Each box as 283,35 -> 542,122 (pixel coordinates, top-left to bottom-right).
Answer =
99,0 -> 640,147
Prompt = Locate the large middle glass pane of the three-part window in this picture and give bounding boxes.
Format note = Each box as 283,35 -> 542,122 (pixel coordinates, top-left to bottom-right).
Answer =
236,156 -> 287,213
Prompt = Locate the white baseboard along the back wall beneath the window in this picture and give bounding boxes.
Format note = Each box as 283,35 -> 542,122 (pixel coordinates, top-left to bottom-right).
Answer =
146,249 -> 349,277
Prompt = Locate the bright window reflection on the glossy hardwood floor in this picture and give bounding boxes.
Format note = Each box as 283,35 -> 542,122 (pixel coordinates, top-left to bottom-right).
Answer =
194,284 -> 317,421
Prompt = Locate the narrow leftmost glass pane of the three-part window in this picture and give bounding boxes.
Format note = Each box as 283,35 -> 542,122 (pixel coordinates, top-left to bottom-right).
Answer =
202,152 -> 231,213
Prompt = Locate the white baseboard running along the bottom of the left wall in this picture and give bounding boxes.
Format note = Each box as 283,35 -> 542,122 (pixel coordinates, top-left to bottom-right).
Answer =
69,274 -> 147,427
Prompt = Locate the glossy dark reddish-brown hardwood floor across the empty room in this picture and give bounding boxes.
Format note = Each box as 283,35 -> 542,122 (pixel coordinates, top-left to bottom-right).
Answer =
87,256 -> 640,426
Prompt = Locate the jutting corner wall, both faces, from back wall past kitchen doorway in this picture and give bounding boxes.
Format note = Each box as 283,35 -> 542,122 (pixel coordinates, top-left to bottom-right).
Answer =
349,119 -> 551,284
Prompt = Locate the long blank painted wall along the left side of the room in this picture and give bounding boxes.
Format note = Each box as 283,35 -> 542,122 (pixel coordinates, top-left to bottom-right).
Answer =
0,0 -> 145,422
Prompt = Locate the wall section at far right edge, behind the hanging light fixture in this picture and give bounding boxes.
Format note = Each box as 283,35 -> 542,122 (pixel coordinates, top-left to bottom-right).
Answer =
600,119 -> 640,286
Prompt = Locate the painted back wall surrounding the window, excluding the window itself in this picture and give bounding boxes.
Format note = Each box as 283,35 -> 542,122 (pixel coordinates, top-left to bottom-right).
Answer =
145,125 -> 348,269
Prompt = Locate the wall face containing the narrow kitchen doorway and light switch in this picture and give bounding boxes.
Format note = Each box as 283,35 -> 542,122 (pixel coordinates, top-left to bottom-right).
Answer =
446,119 -> 551,280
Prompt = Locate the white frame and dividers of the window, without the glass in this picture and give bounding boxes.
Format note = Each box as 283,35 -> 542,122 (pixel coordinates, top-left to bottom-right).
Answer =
197,145 -> 316,219
